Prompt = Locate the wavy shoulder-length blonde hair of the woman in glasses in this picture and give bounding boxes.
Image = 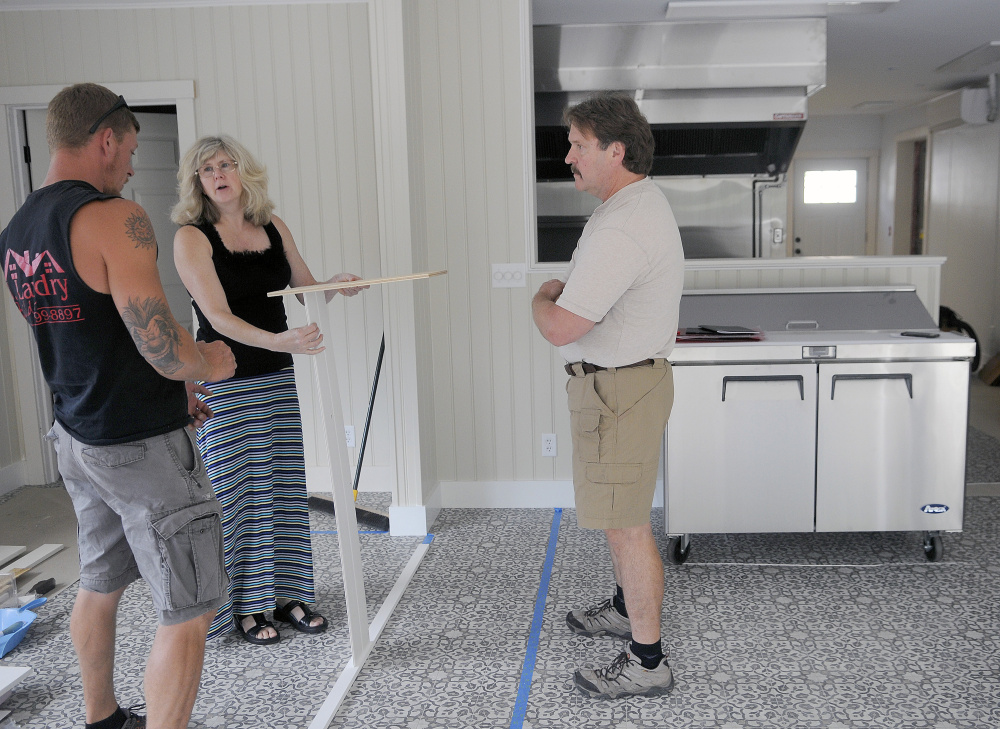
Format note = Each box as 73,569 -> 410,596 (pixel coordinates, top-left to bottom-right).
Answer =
170,134 -> 274,226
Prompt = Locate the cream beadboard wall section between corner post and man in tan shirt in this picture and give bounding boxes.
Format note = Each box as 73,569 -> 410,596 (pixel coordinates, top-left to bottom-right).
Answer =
408,0 -> 571,490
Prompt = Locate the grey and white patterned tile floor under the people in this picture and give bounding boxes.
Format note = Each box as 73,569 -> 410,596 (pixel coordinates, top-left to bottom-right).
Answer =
0,492 -> 1000,729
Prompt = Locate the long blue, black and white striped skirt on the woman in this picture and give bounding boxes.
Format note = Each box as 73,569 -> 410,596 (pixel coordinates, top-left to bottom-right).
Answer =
198,367 -> 315,638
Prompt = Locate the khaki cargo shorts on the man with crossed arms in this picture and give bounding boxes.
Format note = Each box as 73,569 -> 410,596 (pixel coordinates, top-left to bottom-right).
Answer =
566,359 -> 674,529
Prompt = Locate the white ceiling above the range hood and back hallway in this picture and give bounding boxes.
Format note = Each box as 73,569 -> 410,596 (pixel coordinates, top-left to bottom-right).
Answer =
533,0 -> 1000,116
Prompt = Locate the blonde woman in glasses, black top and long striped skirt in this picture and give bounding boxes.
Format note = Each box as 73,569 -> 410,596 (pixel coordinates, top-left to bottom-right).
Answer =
171,136 -> 361,645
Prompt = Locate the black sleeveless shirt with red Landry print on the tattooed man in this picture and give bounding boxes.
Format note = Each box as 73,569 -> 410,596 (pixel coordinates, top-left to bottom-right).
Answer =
0,180 -> 189,445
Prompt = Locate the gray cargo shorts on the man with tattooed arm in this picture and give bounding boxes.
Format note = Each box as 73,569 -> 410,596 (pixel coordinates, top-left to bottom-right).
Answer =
48,422 -> 228,625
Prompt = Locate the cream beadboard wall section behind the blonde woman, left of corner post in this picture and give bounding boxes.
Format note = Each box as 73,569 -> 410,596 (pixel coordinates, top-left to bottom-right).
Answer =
0,3 -> 389,488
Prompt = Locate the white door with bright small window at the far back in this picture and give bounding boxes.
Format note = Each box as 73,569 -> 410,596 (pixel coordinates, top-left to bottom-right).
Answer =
792,159 -> 868,256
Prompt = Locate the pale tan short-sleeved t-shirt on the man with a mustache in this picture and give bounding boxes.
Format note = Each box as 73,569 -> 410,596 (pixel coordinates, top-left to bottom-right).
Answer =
556,178 -> 684,367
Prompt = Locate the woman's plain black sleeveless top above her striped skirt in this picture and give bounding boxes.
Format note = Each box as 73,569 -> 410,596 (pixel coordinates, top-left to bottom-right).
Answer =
193,223 -> 292,377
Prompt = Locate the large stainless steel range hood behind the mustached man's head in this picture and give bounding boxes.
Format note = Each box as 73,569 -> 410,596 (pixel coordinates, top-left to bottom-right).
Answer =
534,18 -> 826,180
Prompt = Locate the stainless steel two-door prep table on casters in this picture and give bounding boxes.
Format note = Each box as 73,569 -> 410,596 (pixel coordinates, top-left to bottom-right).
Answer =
664,287 -> 975,563
